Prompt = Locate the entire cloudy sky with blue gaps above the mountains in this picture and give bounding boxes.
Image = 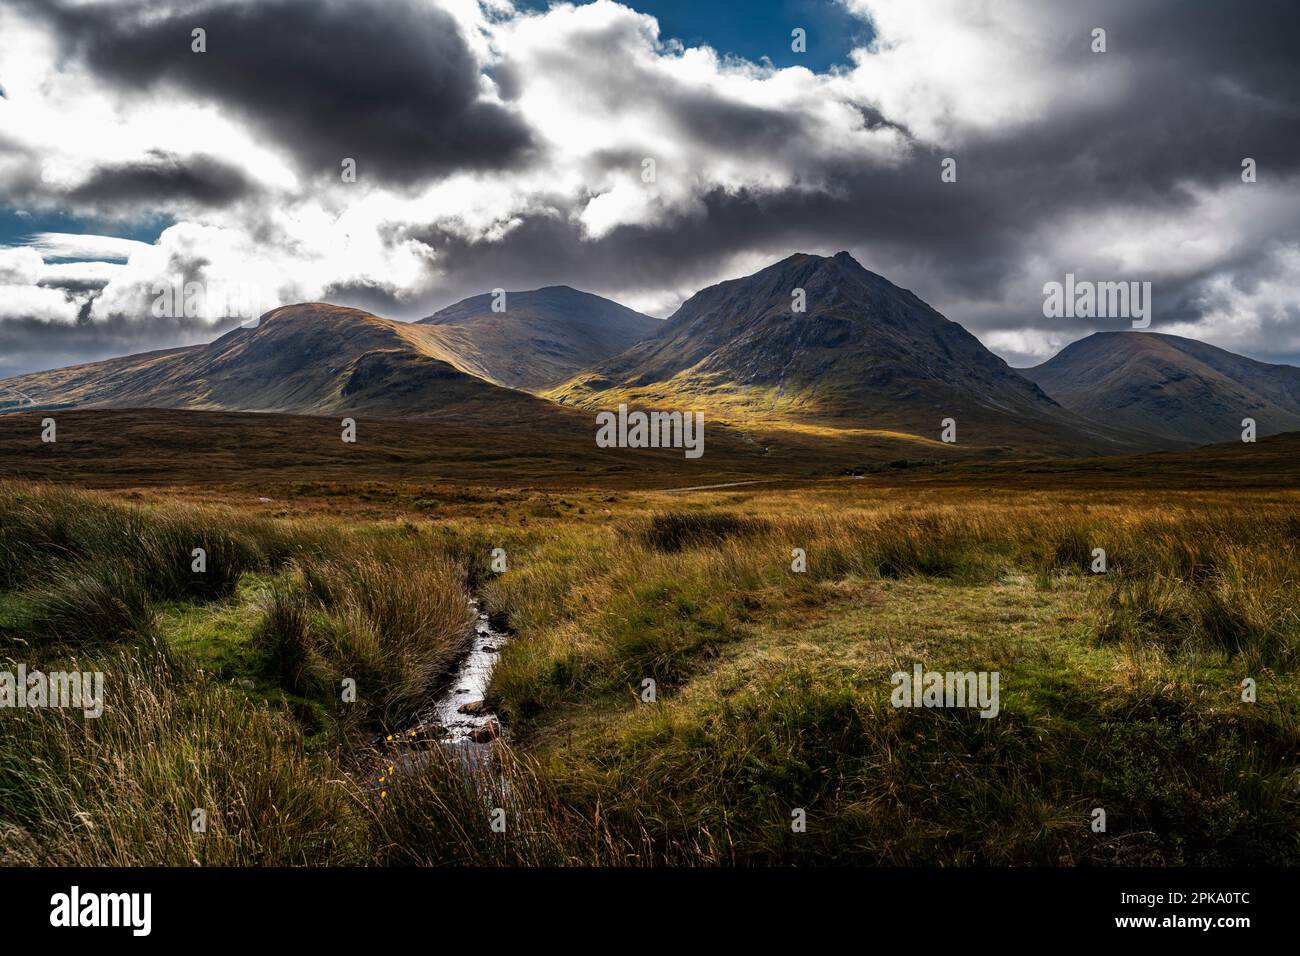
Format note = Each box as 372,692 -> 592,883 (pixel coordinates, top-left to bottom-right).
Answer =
0,0 -> 1300,376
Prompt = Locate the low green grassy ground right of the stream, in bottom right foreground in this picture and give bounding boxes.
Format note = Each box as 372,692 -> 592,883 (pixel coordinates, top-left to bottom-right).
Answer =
520,581 -> 1300,865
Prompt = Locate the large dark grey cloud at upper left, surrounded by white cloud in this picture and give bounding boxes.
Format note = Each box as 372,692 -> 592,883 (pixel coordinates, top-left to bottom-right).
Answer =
27,0 -> 530,183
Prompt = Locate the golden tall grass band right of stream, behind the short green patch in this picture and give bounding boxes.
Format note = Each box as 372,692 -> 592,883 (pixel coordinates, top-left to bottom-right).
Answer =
485,503 -> 1300,717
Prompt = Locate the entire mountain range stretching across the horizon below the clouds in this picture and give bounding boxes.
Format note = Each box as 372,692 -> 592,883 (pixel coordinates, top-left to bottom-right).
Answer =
0,252 -> 1300,454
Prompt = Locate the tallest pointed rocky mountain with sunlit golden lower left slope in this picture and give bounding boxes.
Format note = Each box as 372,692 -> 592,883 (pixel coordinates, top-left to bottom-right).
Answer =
546,252 -> 1151,451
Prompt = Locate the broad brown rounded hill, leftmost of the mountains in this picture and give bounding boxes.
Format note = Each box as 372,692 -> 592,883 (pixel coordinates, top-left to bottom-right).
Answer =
4,303 -> 566,419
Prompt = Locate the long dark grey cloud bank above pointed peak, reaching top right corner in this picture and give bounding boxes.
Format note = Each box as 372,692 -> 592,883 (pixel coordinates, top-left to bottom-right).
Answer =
400,3 -> 1300,356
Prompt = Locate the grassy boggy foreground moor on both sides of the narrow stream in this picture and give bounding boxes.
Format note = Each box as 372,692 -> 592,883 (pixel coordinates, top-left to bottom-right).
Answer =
0,470 -> 1300,865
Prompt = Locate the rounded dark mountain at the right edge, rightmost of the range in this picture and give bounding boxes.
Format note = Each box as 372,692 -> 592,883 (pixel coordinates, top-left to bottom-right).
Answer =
1021,332 -> 1300,444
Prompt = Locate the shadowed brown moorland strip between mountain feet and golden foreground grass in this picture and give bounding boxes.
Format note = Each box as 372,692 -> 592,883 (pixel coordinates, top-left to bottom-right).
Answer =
0,406 -> 1128,497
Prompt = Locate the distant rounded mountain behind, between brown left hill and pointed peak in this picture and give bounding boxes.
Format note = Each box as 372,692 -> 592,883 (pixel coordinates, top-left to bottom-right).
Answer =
420,286 -> 663,392
